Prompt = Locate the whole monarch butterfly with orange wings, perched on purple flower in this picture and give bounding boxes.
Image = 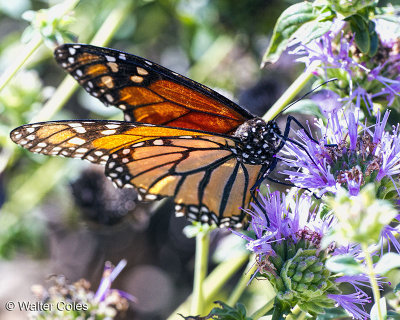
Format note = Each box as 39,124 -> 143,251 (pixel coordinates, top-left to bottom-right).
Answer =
10,44 -> 304,227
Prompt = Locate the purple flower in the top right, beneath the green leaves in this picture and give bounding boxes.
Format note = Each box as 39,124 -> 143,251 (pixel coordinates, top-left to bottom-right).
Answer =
291,19 -> 400,113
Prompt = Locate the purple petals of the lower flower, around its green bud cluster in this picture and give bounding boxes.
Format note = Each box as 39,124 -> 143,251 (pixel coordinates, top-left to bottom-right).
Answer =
233,191 -> 371,319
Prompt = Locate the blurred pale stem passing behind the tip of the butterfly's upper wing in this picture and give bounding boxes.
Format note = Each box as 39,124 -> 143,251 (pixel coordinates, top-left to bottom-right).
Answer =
31,1 -> 130,122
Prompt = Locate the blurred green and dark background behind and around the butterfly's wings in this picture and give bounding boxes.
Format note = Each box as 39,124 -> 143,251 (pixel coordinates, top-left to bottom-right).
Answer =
0,0 -> 303,320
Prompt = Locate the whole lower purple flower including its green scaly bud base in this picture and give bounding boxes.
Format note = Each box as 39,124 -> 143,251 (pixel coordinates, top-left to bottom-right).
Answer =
232,191 -> 370,319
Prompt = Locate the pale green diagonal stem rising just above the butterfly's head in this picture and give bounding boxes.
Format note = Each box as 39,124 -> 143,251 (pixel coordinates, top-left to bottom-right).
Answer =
263,61 -> 319,121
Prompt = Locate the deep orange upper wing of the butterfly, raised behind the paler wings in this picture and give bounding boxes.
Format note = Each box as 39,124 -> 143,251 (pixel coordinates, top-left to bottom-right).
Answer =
54,44 -> 254,134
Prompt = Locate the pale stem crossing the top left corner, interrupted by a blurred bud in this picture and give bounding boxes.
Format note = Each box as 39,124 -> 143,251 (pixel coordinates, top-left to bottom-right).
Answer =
0,0 -> 79,92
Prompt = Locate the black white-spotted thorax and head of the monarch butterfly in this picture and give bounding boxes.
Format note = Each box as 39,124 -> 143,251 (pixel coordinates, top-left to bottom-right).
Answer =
233,118 -> 281,164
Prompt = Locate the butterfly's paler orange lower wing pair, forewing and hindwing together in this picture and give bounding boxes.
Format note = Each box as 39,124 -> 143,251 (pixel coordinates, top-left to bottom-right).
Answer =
10,120 -> 263,227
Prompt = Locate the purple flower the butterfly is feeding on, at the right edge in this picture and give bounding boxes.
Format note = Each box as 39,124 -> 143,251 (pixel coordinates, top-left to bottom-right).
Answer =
279,112 -> 400,196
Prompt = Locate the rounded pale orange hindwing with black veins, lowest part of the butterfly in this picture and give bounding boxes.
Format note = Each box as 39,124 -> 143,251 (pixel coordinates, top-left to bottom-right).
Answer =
106,136 -> 262,227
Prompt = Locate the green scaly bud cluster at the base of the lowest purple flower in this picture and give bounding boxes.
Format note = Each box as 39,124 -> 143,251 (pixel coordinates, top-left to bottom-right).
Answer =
264,240 -> 341,315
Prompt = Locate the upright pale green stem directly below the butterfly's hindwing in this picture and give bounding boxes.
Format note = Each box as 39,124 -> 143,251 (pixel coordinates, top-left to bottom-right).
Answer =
191,230 -> 210,315
